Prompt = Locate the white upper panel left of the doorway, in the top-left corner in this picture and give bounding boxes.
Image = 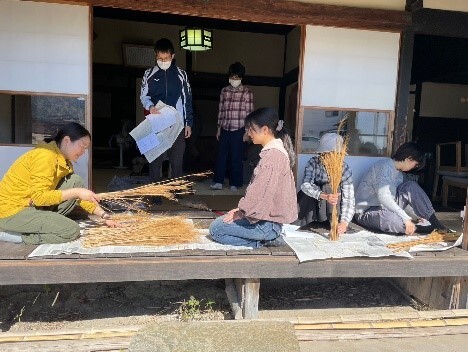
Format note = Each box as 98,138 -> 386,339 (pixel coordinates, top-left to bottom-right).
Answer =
0,0 -> 89,94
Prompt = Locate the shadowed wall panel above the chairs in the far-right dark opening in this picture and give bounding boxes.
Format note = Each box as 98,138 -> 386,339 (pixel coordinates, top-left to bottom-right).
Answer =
419,82 -> 468,119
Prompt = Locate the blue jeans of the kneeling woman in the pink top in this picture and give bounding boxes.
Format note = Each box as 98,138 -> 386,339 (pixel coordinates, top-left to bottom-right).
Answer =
210,216 -> 282,248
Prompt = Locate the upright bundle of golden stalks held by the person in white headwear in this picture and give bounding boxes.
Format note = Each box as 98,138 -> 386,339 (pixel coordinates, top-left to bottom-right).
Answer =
320,137 -> 348,241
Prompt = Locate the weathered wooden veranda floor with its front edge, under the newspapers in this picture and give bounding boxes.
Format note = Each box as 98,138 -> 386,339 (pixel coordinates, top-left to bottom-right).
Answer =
0,211 -> 468,285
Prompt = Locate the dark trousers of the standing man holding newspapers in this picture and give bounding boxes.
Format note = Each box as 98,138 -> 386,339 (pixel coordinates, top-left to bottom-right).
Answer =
149,128 -> 185,182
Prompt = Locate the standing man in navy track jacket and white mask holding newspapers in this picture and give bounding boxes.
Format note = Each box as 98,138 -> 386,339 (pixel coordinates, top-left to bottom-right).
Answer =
140,38 -> 193,182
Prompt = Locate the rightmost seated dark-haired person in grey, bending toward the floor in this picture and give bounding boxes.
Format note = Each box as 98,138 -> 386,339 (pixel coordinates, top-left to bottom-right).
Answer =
354,142 -> 446,235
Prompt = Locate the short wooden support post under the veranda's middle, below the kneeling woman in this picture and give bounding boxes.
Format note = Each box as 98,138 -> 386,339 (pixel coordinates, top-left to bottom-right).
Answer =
226,279 -> 260,319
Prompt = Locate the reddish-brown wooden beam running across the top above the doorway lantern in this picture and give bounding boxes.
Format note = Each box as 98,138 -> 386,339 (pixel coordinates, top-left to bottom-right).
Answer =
54,0 -> 411,32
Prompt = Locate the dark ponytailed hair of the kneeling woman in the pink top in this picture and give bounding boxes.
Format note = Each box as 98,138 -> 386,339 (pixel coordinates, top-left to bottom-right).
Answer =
245,108 -> 296,169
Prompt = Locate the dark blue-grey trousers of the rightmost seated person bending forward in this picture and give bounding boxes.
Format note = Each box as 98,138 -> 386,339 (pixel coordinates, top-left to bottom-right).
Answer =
354,181 -> 435,234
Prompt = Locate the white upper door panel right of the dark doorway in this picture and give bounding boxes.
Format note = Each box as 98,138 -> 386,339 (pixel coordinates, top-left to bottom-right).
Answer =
302,26 -> 400,110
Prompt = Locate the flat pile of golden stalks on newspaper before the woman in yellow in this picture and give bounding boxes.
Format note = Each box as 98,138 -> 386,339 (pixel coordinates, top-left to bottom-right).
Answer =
82,212 -> 199,247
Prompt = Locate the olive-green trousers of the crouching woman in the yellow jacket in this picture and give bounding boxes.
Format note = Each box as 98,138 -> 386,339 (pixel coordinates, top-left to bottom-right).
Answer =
0,174 -> 84,244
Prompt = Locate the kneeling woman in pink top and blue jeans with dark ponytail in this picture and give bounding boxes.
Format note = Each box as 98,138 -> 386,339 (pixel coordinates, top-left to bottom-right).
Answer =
210,108 -> 297,248
